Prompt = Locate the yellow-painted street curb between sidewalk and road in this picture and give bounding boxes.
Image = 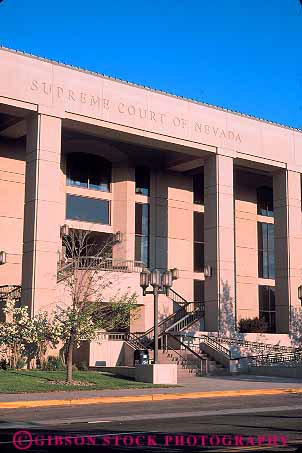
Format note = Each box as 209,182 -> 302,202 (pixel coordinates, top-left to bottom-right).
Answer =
0,387 -> 302,409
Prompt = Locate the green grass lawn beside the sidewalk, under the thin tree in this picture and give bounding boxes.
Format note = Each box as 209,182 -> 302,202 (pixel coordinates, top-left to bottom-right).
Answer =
0,370 -> 168,393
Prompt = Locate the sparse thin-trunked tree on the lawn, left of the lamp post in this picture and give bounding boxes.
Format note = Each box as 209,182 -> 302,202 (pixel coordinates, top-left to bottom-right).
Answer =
55,230 -> 137,383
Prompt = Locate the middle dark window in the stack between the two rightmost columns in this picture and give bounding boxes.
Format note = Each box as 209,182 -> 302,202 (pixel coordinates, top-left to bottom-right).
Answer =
258,222 -> 275,278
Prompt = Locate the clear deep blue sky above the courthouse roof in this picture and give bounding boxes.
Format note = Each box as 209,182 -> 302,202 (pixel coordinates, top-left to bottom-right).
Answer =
0,0 -> 302,128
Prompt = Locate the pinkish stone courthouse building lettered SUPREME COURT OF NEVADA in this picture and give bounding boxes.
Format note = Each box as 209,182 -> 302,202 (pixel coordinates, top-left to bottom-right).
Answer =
0,48 -> 302,346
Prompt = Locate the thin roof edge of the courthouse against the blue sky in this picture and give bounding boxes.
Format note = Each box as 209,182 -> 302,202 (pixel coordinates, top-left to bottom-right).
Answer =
0,45 -> 302,133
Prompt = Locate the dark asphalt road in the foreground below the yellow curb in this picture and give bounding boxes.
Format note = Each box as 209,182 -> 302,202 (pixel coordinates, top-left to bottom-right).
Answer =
0,394 -> 302,453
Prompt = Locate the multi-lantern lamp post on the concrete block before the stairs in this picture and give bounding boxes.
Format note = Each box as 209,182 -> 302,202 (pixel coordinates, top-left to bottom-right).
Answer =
140,268 -> 179,363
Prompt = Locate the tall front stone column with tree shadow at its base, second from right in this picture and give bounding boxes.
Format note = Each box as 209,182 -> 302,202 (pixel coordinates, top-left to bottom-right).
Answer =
204,155 -> 236,335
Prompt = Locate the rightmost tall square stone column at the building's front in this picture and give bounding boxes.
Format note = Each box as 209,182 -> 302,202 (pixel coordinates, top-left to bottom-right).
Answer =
274,170 -> 302,333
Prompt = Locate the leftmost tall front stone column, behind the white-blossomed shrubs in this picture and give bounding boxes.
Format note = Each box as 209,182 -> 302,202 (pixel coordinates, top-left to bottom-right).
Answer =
22,114 -> 65,315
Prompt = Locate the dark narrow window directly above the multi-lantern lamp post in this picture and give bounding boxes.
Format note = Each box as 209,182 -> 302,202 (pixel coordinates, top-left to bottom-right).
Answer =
135,203 -> 149,266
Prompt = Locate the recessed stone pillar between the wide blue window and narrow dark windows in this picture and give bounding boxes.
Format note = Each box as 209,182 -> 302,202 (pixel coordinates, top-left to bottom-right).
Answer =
112,161 -> 135,261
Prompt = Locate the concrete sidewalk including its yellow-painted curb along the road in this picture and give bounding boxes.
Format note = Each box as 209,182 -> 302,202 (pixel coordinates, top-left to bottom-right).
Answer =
0,376 -> 302,409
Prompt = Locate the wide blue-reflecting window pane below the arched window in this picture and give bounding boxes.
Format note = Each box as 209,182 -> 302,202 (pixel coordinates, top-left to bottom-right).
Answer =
66,195 -> 109,225
